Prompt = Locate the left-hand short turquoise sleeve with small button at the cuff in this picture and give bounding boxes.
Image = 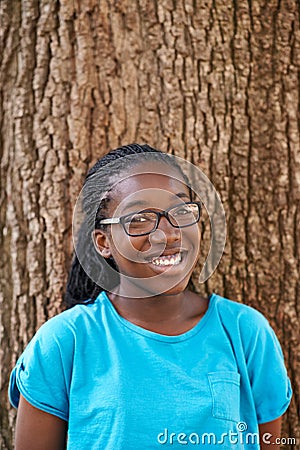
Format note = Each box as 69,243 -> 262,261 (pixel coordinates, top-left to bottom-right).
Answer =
8,318 -> 72,420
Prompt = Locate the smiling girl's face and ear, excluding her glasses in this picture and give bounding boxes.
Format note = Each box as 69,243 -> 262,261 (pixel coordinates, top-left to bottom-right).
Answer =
95,163 -> 200,295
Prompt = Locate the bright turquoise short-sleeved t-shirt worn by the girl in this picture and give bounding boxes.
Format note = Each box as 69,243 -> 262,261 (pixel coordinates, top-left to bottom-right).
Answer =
9,292 -> 291,450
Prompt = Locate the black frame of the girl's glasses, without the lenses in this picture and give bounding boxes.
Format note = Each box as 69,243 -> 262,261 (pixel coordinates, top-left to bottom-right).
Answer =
98,201 -> 203,237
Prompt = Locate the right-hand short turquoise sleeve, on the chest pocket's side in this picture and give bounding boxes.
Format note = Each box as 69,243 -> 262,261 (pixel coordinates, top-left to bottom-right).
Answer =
241,311 -> 292,423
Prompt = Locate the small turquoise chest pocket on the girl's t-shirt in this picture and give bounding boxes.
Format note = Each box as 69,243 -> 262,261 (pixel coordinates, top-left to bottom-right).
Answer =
207,372 -> 240,422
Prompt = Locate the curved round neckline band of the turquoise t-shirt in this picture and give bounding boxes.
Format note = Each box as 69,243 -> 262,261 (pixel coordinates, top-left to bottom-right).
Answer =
98,291 -> 216,343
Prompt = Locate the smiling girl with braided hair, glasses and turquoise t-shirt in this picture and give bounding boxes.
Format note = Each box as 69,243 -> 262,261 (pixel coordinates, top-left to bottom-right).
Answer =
9,144 -> 291,450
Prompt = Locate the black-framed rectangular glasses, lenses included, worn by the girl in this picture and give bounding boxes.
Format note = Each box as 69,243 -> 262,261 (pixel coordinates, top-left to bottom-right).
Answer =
98,202 -> 202,236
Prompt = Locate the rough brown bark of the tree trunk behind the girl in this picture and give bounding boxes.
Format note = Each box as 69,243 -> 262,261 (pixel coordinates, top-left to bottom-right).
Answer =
0,0 -> 300,449
